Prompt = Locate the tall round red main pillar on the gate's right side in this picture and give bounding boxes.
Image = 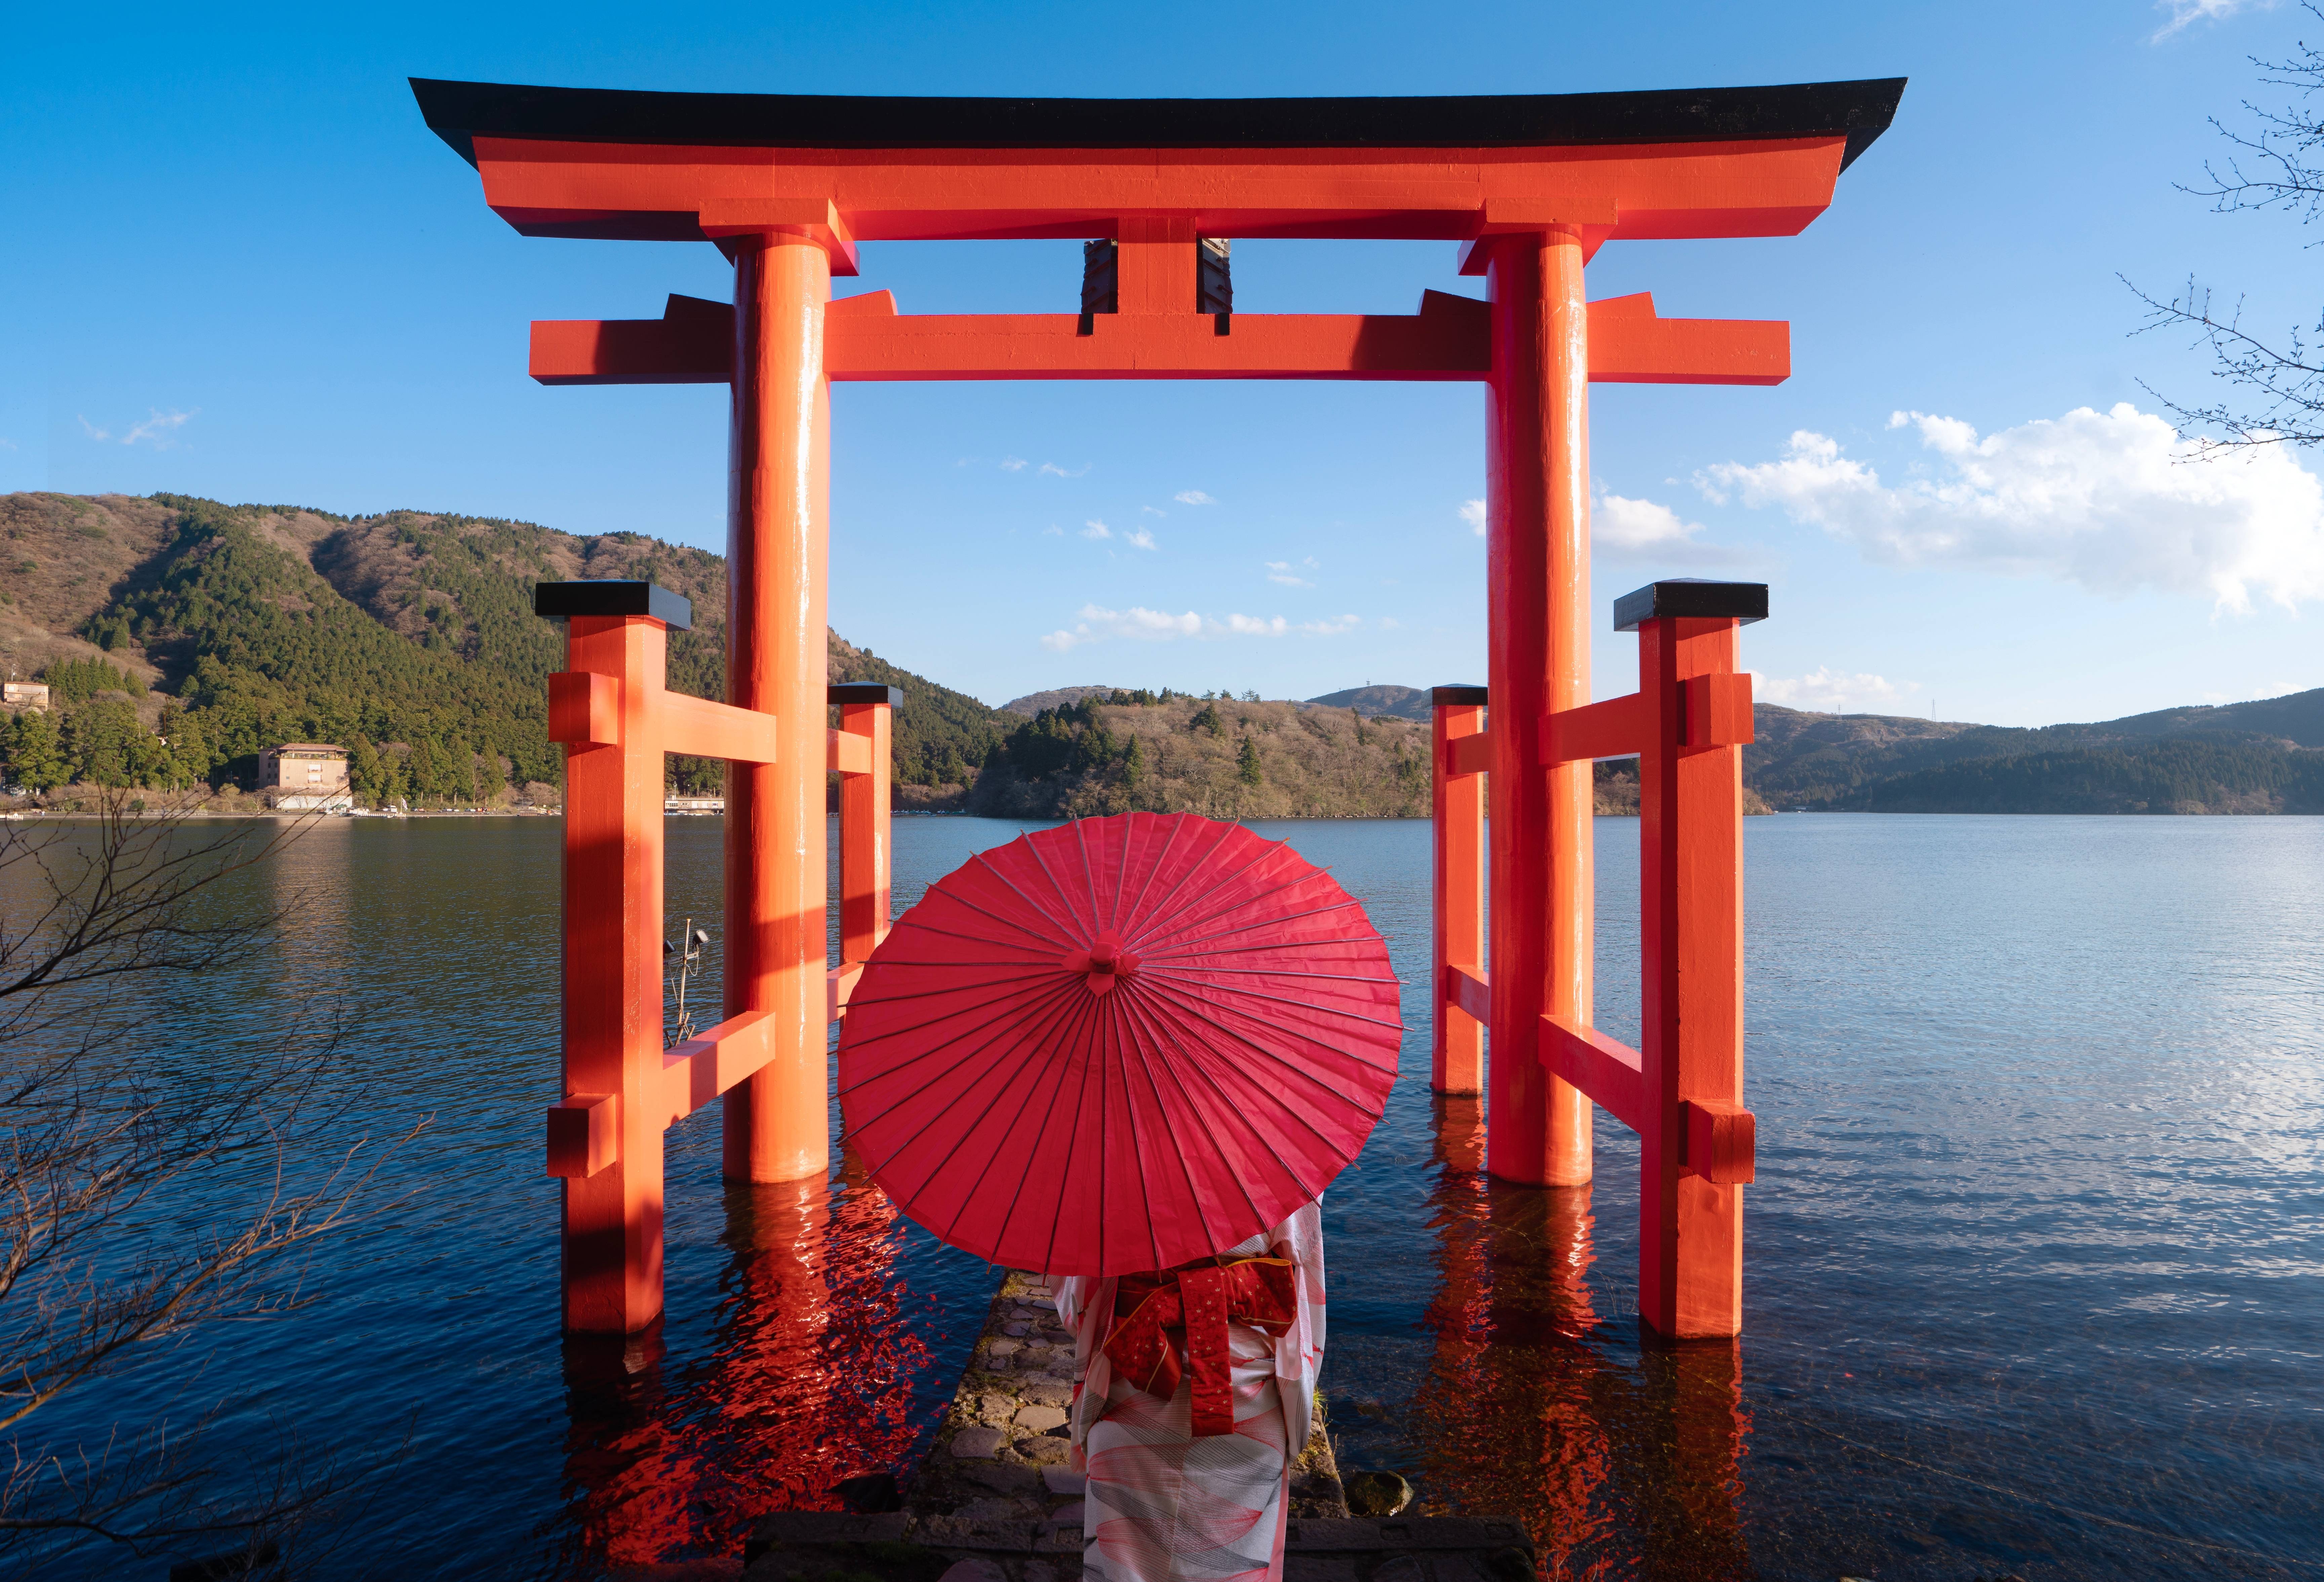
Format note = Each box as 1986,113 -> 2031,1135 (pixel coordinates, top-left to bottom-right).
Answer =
1485,228 -> 1592,1187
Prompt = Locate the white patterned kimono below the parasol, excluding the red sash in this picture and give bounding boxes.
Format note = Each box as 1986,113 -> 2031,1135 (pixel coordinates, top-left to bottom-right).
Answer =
1050,1203 -> 1322,1582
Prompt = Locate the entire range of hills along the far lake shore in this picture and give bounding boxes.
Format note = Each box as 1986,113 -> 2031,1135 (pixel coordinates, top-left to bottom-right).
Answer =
0,492 -> 2324,818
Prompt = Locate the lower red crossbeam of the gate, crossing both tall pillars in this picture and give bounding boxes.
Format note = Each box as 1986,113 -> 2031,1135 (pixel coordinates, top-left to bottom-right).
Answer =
532,290 -> 1792,386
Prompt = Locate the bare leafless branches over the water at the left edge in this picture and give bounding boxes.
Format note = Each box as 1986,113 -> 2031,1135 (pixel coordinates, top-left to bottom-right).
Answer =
0,797 -> 413,1575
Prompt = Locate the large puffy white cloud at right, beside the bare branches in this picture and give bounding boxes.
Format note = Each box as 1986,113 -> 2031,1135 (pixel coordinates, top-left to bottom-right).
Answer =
1696,402 -> 2324,611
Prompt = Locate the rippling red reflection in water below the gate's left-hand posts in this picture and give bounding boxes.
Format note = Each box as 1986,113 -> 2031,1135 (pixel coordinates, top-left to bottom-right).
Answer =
555,1180 -> 941,1573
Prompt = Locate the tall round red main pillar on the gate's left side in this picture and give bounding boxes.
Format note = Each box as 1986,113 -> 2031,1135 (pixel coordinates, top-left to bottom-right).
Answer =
725,235 -> 832,1180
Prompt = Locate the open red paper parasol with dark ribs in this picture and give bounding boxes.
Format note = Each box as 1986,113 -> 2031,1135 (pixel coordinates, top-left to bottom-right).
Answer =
839,813 -> 1401,1275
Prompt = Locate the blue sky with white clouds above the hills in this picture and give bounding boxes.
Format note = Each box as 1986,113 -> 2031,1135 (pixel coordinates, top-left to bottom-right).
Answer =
0,0 -> 2324,725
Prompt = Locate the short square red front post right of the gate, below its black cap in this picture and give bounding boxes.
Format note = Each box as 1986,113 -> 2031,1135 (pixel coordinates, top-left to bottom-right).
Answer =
1638,613 -> 1764,1338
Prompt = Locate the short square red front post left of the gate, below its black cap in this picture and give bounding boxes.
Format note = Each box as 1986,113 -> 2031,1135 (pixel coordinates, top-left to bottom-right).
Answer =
551,616 -> 667,1336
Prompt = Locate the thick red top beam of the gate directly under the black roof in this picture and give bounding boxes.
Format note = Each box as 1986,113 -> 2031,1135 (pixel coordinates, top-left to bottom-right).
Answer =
474,135 -> 1845,242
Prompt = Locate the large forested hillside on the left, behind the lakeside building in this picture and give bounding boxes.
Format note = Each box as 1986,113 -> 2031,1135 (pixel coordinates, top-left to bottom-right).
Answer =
0,495 -> 1002,804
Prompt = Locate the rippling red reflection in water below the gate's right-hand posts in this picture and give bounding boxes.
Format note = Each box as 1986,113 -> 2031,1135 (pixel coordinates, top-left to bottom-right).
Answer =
1408,1096 -> 1750,1582
